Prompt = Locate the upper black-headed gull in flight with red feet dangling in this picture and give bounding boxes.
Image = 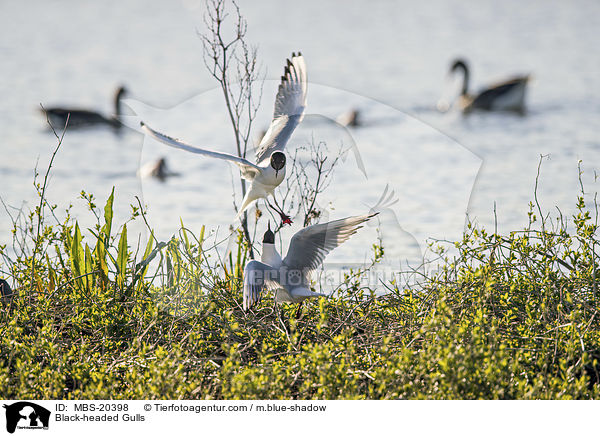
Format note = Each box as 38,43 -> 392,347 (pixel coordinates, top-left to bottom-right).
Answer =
141,53 -> 307,224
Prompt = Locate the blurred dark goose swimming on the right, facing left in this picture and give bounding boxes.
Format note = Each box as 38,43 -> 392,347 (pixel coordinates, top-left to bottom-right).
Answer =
442,59 -> 529,113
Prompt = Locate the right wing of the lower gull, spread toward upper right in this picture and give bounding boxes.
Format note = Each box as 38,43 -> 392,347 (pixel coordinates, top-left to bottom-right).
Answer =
283,213 -> 377,272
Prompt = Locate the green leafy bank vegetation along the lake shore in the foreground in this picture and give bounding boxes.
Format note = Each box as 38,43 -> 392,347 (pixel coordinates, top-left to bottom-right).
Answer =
0,177 -> 600,399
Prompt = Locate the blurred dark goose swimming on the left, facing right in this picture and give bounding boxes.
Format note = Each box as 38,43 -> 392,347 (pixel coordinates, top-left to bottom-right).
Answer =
44,86 -> 127,128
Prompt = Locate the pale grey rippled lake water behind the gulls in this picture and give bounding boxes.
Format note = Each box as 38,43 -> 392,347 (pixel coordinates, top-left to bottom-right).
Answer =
0,0 -> 600,276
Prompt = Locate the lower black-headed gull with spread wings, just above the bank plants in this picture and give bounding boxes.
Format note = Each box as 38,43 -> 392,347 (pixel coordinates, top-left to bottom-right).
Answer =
244,213 -> 377,310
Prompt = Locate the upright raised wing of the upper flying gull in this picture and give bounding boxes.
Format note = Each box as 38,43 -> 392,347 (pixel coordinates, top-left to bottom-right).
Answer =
256,53 -> 308,164
